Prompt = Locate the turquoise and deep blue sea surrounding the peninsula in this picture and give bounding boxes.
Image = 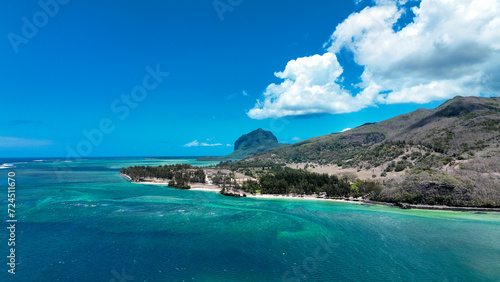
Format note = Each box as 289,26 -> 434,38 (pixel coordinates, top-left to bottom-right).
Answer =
0,158 -> 500,281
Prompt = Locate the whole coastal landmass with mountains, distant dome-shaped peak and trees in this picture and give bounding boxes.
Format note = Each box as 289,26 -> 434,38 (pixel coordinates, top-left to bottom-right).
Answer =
124,97 -> 500,210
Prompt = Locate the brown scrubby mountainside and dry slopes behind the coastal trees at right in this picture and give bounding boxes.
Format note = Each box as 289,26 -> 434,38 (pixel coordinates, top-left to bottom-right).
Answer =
242,97 -> 500,206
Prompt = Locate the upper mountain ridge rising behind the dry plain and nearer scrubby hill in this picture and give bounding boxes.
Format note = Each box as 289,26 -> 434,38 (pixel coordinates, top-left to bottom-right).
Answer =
253,97 -> 500,163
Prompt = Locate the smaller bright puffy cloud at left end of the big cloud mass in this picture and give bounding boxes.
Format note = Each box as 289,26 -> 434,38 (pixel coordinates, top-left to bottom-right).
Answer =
248,53 -> 376,119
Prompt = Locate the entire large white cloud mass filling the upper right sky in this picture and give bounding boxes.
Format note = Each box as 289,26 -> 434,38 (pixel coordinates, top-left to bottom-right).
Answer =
247,0 -> 500,119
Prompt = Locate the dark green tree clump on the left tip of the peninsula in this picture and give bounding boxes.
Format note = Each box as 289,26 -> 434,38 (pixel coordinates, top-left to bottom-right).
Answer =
120,164 -> 205,189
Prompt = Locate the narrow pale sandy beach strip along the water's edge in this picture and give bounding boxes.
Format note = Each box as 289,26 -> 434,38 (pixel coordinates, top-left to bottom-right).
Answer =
119,173 -> 500,212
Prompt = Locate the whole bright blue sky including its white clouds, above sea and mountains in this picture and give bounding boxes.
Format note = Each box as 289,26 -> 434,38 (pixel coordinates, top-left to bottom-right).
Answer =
0,0 -> 500,157
